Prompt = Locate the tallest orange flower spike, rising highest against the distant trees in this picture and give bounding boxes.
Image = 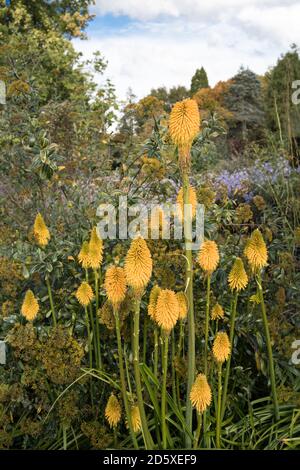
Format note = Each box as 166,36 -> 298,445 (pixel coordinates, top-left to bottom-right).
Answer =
169,99 -> 200,149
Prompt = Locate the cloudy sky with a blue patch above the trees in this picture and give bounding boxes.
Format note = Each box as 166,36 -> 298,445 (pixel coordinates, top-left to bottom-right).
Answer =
74,0 -> 300,99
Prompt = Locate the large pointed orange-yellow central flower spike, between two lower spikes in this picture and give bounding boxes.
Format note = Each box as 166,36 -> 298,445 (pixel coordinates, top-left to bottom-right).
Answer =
124,237 -> 152,290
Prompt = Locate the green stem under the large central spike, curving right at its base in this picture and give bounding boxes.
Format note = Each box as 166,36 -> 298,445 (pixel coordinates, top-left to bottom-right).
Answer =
133,299 -> 153,450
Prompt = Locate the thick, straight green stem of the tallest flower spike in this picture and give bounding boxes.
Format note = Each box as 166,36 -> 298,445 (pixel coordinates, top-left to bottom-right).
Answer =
182,170 -> 195,449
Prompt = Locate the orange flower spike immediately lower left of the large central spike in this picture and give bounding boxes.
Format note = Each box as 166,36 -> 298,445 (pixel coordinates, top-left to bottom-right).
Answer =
104,266 -> 126,307
